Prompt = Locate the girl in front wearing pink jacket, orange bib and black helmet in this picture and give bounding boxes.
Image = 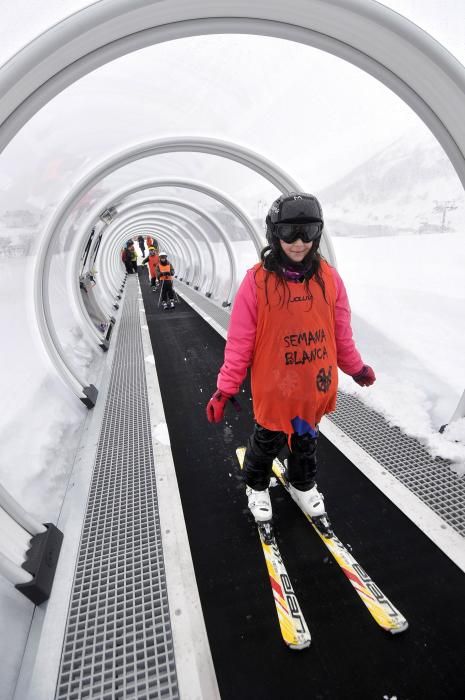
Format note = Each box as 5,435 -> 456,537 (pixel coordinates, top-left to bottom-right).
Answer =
207,192 -> 376,522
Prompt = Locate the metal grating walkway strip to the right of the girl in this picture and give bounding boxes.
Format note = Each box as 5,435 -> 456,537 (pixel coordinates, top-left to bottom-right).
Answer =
328,392 -> 465,536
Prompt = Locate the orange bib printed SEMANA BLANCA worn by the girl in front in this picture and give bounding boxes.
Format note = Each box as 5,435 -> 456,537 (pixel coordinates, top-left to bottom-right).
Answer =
251,261 -> 338,435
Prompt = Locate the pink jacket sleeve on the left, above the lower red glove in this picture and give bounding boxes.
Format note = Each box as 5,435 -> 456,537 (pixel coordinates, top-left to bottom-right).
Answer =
217,270 -> 258,395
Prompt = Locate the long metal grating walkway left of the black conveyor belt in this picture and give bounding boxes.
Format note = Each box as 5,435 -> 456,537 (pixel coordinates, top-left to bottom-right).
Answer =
56,279 -> 179,700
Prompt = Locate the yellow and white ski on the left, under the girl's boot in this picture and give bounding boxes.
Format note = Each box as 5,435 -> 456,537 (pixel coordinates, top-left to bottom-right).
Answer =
236,447 -> 311,651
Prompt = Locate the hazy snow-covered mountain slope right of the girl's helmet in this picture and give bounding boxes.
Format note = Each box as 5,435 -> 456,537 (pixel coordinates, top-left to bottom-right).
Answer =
319,130 -> 465,237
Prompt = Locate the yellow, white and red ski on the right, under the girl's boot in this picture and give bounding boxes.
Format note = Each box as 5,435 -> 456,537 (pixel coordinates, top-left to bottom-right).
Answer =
273,459 -> 408,634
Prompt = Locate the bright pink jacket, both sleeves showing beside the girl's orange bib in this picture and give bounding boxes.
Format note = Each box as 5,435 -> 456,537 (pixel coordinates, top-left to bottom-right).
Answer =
217,267 -> 363,395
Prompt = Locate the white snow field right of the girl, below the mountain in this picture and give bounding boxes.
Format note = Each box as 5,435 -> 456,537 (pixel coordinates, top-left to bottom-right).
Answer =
333,233 -> 465,473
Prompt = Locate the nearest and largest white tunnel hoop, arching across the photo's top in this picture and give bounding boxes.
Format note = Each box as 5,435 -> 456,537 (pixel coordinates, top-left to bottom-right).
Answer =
0,0 -> 465,183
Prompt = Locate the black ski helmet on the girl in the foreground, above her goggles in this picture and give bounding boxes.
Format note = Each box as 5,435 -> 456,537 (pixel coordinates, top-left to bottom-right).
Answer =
265,192 -> 324,246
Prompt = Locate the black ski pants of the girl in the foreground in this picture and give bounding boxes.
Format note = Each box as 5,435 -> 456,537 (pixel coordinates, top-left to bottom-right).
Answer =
244,423 -> 317,491
